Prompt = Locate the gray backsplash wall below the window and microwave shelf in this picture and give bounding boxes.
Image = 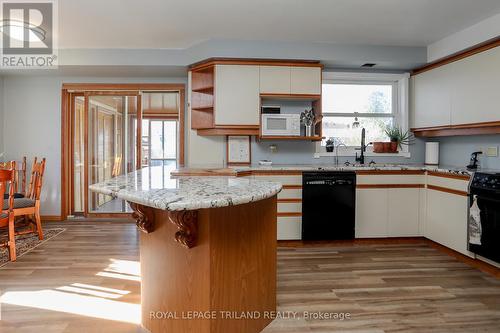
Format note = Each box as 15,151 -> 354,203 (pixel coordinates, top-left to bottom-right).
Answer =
252,139 -> 425,164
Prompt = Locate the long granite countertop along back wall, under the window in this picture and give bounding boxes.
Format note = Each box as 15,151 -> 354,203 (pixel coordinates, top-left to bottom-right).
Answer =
172,164 -> 473,176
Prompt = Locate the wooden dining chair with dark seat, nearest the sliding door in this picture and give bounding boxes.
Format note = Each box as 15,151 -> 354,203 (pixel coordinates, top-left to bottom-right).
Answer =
3,157 -> 45,240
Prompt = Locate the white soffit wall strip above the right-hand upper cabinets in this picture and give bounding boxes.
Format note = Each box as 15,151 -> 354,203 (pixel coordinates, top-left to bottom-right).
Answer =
427,14 -> 500,62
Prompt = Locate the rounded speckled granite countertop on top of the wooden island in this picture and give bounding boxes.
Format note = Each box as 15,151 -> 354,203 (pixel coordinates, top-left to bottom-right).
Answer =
89,166 -> 281,210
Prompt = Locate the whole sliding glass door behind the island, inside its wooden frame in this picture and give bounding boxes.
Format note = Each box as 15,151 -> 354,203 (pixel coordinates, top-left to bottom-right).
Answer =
70,91 -> 180,217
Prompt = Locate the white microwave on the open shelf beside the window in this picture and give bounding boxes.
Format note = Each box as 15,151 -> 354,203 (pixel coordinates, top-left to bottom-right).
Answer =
261,114 -> 300,136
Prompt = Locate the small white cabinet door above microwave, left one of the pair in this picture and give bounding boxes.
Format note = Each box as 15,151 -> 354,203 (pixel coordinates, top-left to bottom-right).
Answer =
260,66 -> 290,94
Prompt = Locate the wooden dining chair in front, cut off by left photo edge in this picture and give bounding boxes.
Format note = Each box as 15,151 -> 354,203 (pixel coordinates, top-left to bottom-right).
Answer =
0,169 -> 16,261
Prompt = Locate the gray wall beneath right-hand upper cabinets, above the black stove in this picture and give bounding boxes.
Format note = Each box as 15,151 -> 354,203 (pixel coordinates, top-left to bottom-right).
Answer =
428,135 -> 500,170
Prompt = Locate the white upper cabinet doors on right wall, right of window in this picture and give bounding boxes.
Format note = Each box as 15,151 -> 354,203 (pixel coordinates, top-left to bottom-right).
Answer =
412,47 -> 500,128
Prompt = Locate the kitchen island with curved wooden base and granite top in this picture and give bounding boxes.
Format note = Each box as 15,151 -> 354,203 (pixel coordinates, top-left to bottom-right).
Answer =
90,167 -> 281,333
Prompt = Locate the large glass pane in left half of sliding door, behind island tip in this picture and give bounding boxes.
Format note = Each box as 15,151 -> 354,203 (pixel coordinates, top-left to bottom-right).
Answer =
88,95 -> 137,213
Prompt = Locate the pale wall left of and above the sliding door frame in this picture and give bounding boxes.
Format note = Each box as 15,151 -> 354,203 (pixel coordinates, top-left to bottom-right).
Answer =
0,76 -> 186,215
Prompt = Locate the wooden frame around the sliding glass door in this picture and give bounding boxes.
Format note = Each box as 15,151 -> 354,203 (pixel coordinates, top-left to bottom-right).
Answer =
60,83 -> 186,221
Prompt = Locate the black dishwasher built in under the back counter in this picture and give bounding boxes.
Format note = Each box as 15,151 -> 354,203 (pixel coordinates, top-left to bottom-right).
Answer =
302,171 -> 356,240
